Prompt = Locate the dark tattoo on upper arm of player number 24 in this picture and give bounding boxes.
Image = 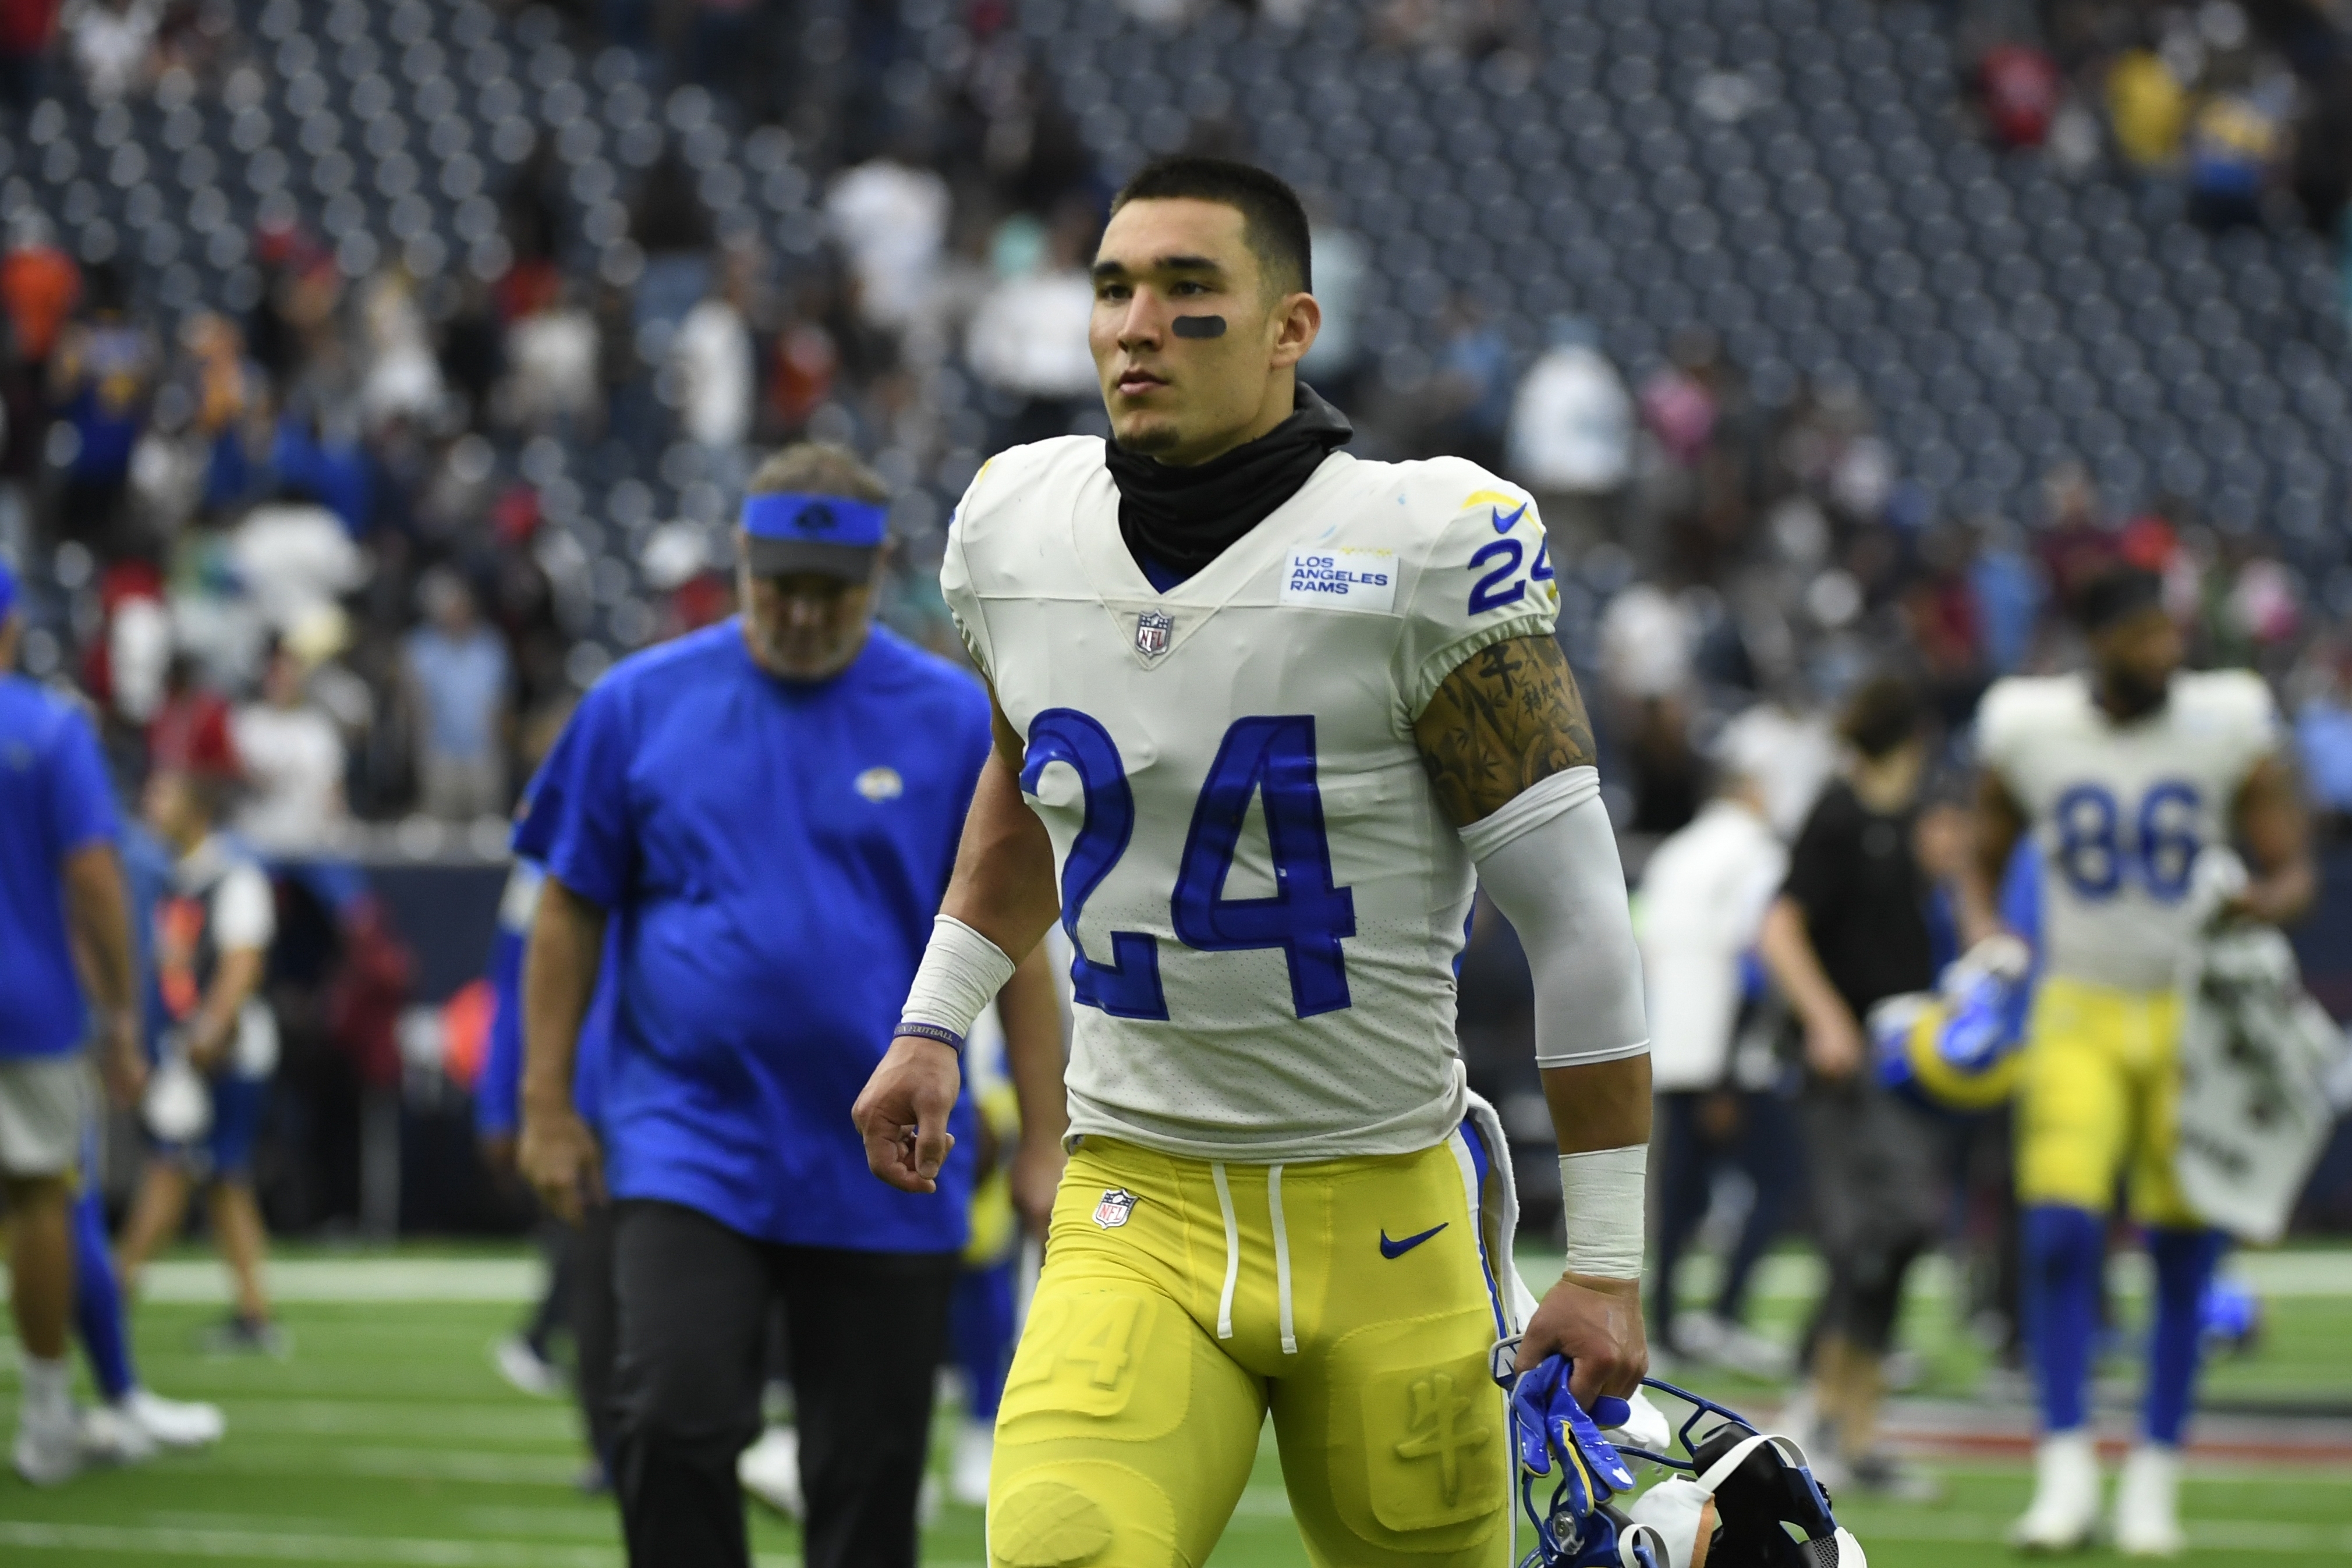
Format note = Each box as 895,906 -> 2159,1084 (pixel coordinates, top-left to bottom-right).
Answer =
1414,637 -> 1597,828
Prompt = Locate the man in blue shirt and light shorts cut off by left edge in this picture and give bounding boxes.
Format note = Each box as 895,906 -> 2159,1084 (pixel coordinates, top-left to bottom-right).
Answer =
0,564 -> 143,1486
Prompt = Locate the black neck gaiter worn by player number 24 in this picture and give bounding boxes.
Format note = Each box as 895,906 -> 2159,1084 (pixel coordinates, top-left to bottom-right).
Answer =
1103,381 -> 1355,581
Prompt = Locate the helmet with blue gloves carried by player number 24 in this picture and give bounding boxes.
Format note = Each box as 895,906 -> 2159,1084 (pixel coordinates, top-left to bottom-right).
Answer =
1496,1340 -> 1868,1568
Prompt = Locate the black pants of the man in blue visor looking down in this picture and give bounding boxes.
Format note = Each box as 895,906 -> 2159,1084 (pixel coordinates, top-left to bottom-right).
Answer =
614,1201 -> 955,1568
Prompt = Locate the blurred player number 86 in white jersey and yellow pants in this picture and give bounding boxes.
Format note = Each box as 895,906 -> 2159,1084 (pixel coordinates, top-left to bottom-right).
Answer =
1971,566 -> 2314,1556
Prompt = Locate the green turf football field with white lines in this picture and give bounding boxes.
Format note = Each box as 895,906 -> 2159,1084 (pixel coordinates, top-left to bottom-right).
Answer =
0,1253 -> 2352,1568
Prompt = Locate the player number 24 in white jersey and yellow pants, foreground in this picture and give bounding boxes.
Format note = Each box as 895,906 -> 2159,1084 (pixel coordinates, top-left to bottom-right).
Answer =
856,158 -> 1649,1568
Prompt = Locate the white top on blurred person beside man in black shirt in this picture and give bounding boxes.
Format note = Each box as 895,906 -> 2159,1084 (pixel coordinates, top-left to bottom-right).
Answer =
1635,799 -> 1787,1091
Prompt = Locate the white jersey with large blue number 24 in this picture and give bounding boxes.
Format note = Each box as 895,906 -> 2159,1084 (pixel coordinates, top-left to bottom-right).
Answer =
941,437 -> 1560,1161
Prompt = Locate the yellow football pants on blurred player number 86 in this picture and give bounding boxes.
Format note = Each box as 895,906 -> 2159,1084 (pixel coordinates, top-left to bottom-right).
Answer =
2018,975 -> 2201,1227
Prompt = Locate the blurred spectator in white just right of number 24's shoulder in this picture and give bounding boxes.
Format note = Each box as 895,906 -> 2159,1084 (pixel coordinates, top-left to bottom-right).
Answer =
1508,315 -> 1632,543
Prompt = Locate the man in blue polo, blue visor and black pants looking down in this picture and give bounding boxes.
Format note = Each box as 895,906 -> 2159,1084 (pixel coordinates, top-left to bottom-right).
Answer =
515,446 -> 1063,1568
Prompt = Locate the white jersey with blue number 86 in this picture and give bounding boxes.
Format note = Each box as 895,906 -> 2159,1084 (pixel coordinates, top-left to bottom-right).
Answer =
1976,670 -> 2279,989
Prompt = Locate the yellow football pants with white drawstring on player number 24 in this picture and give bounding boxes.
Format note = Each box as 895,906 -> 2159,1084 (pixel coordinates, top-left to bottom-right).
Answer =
988,1133 -> 1512,1568
